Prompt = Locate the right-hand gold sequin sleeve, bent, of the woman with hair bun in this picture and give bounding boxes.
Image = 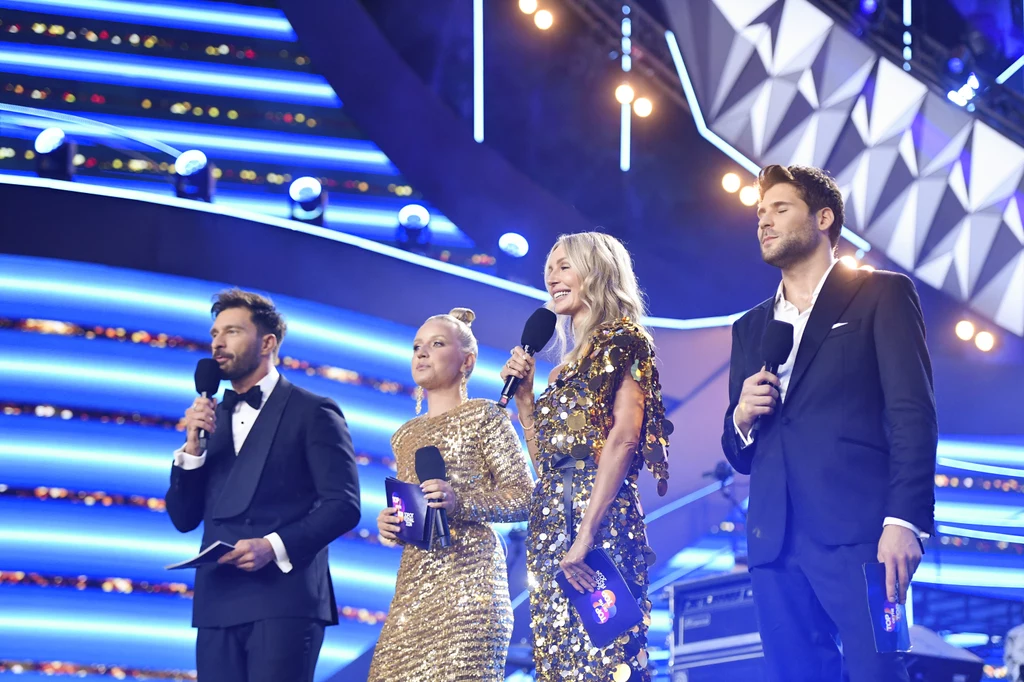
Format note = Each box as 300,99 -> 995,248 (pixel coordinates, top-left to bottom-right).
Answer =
452,402 -> 534,523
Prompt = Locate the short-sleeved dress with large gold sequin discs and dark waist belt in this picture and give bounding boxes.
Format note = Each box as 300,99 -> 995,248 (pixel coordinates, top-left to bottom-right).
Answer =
526,319 -> 672,682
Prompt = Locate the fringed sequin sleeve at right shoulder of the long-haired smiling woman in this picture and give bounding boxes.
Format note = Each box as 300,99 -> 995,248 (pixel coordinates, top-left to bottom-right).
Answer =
604,319 -> 673,495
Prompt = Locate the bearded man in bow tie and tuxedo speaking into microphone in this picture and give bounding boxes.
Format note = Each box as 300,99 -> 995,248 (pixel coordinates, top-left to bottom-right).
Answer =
167,289 -> 359,682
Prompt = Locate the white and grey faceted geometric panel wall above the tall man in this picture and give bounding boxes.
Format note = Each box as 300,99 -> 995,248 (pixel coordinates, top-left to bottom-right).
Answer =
665,0 -> 1024,336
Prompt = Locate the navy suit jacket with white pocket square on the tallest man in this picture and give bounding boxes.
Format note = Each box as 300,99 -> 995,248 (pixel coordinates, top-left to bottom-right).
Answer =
722,265 -> 938,565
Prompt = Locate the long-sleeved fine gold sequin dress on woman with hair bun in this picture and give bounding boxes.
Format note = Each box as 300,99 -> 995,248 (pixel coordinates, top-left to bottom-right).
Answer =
369,399 -> 534,682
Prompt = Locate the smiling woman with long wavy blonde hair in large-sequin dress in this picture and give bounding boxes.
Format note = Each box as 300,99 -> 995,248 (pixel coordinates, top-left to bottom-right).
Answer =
502,232 -> 671,682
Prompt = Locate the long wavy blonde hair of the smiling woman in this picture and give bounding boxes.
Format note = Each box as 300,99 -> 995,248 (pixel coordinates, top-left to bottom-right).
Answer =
545,232 -> 653,363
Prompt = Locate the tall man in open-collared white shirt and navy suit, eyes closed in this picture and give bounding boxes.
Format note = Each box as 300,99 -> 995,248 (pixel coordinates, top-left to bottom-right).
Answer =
722,166 -> 938,682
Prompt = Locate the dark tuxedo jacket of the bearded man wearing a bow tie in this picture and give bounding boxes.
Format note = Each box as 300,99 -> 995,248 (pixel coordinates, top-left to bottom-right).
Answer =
166,377 -> 359,628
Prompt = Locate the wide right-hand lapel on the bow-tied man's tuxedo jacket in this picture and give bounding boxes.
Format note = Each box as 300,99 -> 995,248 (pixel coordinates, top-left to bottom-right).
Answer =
213,377 -> 292,519
